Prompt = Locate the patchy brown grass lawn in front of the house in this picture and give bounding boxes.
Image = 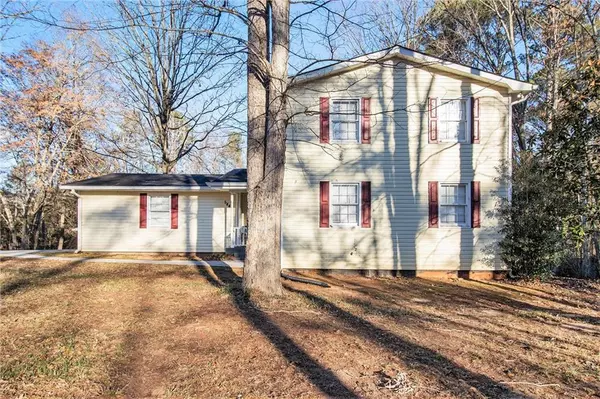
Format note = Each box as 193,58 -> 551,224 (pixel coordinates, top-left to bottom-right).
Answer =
0,259 -> 600,398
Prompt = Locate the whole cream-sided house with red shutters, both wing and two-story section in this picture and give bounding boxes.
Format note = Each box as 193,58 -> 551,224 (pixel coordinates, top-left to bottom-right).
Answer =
63,47 -> 533,273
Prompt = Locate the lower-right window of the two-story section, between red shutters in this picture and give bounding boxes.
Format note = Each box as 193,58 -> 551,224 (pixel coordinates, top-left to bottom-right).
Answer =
440,183 -> 470,227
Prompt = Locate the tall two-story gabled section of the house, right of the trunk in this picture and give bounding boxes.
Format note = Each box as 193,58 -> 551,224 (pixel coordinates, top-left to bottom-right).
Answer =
282,47 -> 533,278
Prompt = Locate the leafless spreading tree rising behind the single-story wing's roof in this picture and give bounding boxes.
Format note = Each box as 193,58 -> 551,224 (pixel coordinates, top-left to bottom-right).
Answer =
106,0 -> 243,173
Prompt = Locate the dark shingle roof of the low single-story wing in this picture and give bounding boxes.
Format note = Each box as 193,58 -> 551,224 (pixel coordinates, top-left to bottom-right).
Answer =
62,169 -> 247,188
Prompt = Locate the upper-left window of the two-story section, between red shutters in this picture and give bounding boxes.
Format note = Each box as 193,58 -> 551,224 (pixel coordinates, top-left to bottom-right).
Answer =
329,99 -> 360,143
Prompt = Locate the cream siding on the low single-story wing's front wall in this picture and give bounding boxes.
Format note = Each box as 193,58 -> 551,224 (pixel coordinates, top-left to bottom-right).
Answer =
79,191 -> 233,252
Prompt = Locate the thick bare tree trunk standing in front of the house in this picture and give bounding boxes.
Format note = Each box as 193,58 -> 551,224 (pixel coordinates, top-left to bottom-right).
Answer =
244,0 -> 289,295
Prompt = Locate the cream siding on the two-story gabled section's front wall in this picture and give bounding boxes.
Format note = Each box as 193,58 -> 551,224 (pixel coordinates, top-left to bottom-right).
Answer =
282,60 -> 510,270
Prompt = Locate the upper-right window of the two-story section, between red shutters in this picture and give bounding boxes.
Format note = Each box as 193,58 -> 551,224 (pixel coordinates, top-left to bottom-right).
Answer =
437,98 -> 470,143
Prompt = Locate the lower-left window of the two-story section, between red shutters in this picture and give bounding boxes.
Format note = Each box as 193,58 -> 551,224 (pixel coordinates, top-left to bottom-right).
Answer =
331,183 -> 360,226
